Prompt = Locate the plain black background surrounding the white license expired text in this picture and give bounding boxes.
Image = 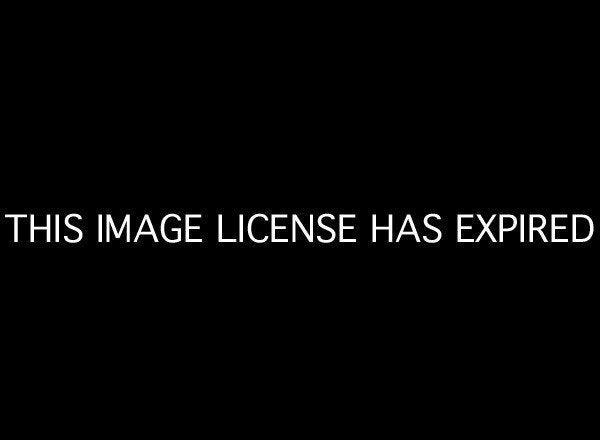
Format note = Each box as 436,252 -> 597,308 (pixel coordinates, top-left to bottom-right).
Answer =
1,5 -> 598,433
